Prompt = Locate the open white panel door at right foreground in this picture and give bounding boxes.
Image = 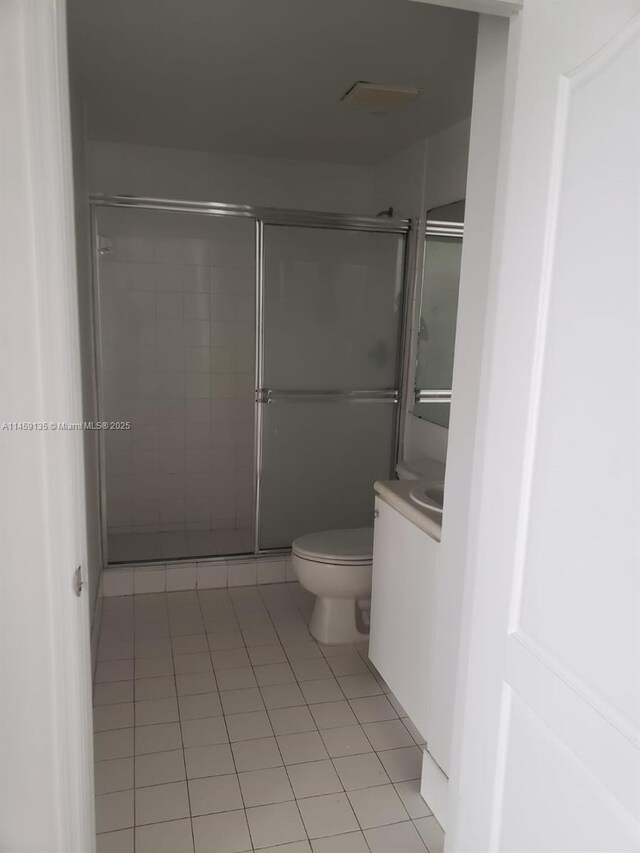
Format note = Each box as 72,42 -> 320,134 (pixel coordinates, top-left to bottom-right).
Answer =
446,0 -> 640,853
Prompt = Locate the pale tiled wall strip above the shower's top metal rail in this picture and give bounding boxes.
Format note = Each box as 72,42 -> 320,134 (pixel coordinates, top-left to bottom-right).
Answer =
88,141 -> 374,214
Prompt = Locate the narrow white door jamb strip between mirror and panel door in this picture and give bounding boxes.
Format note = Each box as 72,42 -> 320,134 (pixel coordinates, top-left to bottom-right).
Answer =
428,16 -> 509,774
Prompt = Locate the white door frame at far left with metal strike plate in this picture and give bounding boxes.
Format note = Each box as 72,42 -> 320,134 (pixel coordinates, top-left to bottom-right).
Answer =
0,0 -> 95,853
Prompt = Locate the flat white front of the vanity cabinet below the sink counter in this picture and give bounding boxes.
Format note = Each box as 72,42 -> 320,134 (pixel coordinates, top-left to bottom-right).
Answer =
369,496 -> 440,739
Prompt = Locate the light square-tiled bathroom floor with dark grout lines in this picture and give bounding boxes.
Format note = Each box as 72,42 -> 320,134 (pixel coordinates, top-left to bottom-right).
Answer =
94,583 -> 444,853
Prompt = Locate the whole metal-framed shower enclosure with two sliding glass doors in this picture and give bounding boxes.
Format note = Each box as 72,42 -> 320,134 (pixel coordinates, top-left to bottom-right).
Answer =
92,197 -> 408,563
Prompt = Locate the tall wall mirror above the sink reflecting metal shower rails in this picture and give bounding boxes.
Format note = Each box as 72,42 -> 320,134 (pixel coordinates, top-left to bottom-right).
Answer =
413,201 -> 464,427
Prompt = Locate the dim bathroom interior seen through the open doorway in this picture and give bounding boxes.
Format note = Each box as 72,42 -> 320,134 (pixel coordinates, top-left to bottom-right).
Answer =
68,0 -> 484,853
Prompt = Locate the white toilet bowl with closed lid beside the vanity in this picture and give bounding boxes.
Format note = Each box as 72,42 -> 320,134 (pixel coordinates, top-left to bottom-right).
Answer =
292,527 -> 373,645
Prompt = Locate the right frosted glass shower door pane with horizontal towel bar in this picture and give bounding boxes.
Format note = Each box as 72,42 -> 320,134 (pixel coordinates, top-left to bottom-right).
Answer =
258,225 -> 405,550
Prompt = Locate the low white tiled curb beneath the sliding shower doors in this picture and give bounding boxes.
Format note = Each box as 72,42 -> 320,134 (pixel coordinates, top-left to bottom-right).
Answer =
103,556 -> 296,598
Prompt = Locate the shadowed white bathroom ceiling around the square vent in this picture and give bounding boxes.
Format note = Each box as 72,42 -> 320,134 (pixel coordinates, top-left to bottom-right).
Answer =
68,0 -> 477,164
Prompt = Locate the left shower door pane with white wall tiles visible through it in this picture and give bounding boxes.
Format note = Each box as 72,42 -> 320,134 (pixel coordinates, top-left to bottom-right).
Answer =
98,208 -> 255,548
